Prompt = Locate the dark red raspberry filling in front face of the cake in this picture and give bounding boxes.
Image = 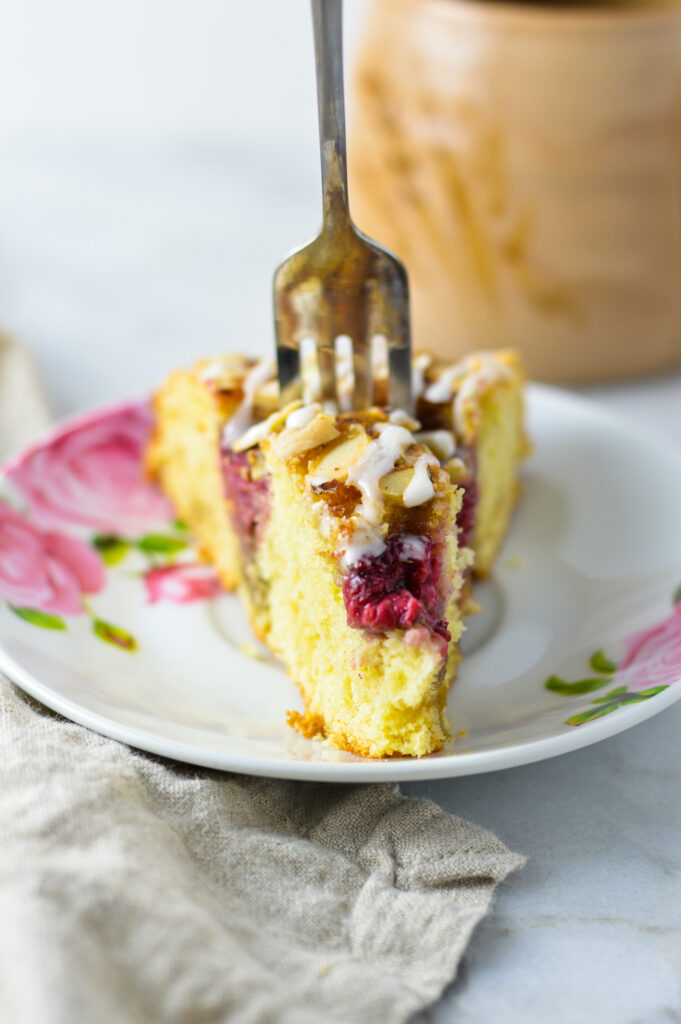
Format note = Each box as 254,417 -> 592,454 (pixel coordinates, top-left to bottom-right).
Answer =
343,535 -> 451,643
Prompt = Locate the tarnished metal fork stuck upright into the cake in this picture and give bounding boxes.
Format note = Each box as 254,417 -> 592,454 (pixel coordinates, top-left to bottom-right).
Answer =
274,0 -> 412,412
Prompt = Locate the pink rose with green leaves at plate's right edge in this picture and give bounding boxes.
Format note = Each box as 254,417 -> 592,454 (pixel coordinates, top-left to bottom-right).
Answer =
544,592 -> 681,725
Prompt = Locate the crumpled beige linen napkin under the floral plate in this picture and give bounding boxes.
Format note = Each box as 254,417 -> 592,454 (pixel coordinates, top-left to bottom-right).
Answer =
0,333 -> 522,1024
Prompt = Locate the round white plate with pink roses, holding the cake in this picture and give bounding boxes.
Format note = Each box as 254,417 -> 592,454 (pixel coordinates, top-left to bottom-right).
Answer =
0,387 -> 681,781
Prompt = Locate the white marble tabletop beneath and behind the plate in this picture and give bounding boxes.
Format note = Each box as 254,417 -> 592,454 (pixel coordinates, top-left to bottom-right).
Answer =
0,149 -> 681,1024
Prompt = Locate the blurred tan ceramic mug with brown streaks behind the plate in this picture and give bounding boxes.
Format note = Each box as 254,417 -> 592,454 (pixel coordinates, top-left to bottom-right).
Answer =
350,0 -> 681,381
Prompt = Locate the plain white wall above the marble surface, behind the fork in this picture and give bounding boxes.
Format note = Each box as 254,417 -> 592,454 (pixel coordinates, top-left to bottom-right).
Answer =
0,0 -> 372,149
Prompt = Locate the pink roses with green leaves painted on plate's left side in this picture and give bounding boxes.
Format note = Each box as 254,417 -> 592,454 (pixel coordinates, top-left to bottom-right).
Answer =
0,403 -> 220,651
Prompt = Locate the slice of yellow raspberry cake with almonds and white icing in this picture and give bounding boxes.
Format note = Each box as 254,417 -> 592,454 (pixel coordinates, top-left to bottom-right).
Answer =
148,355 -> 521,757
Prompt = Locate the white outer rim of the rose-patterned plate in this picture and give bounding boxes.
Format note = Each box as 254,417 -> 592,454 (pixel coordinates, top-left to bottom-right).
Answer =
0,383 -> 681,782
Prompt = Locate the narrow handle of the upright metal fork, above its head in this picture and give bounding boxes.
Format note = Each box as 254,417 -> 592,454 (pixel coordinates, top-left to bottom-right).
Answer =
311,0 -> 350,220
